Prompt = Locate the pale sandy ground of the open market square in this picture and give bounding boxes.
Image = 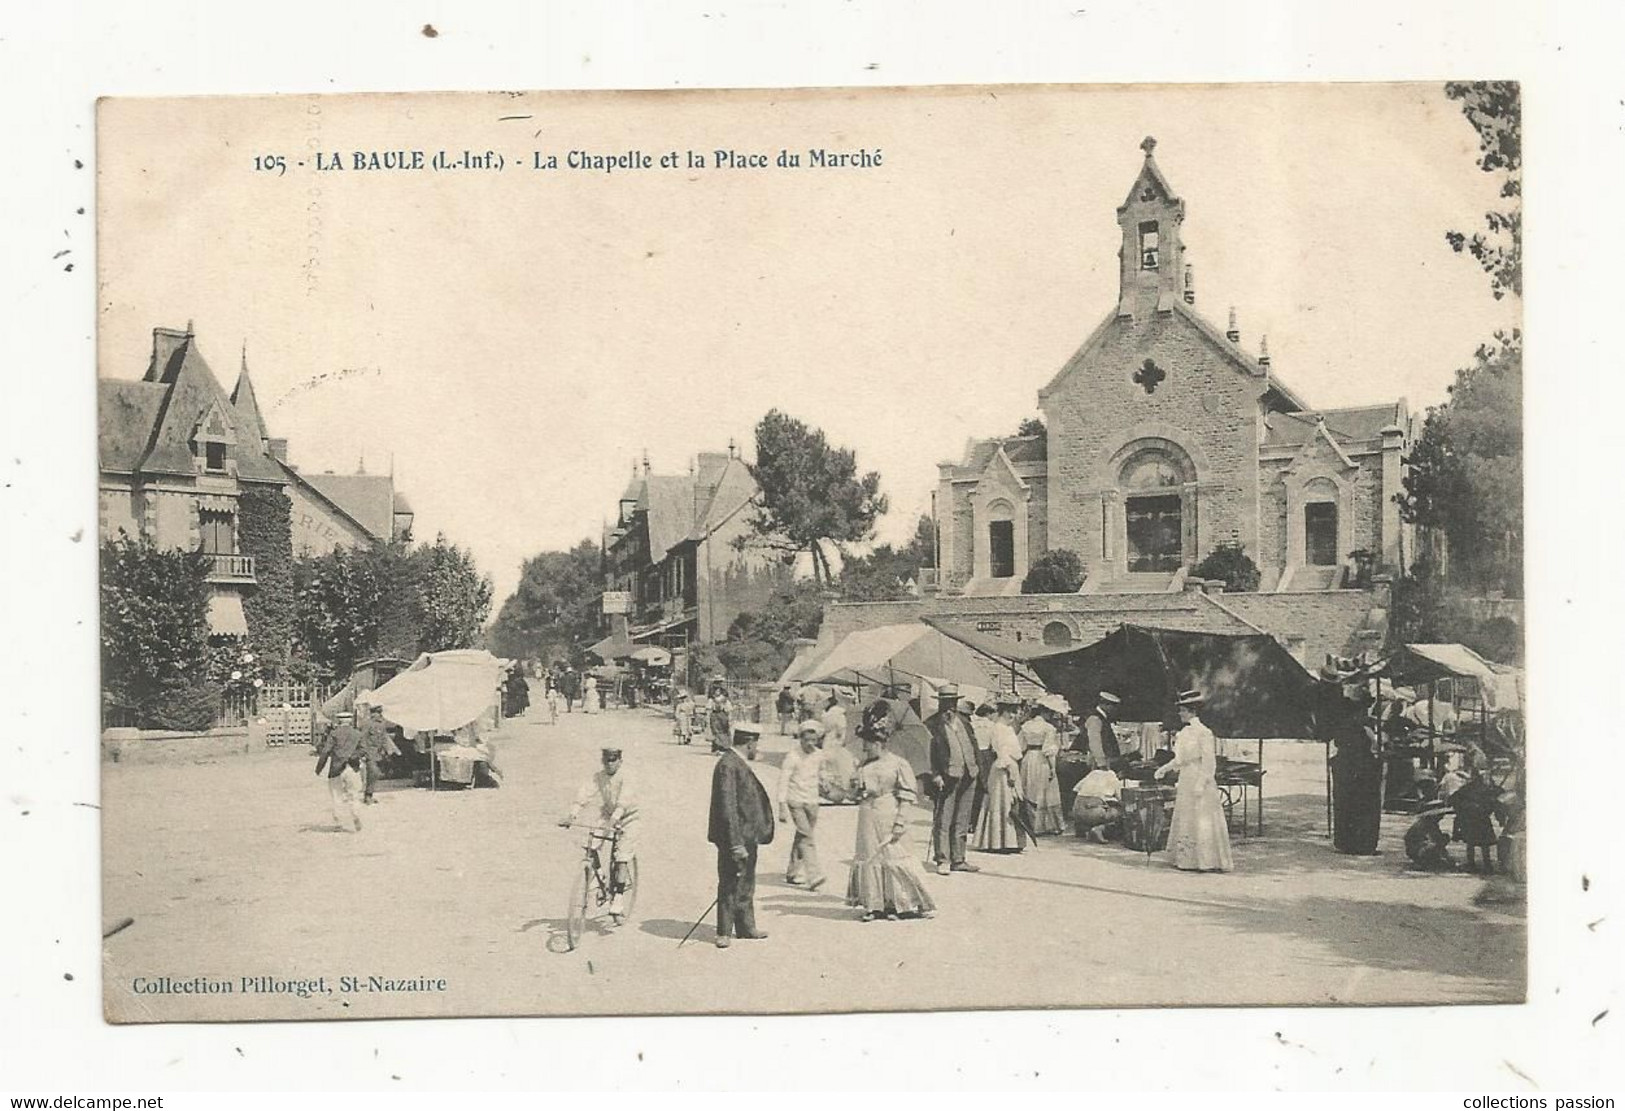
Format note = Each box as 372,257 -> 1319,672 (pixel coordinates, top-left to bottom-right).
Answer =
102,703 -> 1526,1022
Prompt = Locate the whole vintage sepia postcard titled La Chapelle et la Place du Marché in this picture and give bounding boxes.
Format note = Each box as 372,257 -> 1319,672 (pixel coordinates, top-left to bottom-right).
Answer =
96,81 -> 1528,1023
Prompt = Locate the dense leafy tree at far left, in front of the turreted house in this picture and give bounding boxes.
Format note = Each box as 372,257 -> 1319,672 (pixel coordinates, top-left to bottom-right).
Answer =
101,536 -> 219,728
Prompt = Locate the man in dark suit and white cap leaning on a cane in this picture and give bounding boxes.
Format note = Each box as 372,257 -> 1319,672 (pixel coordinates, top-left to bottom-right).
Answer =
707,721 -> 774,949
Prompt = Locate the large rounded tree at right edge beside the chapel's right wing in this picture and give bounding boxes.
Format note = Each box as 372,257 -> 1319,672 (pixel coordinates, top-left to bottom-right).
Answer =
1399,330 -> 1523,596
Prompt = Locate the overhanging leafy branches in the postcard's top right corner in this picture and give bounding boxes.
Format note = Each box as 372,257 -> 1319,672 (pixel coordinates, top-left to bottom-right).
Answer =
1445,81 -> 1523,300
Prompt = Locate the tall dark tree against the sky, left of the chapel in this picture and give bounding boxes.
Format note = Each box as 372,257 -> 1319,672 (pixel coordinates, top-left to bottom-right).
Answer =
746,409 -> 887,585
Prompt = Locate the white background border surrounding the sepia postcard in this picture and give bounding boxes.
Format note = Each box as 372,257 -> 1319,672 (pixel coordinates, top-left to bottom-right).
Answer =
0,0 -> 1625,1106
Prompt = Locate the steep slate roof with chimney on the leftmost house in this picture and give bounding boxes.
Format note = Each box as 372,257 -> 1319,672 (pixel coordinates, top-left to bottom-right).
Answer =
98,328 -> 283,482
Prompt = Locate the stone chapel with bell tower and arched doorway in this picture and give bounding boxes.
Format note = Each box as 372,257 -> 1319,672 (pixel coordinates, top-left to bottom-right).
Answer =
936,138 -> 1412,598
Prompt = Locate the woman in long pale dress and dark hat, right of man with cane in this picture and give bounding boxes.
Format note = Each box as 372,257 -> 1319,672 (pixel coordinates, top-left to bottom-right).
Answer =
847,700 -> 936,923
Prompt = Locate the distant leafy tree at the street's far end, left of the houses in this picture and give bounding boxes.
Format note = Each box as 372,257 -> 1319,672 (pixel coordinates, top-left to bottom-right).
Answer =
491,539 -> 605,664
